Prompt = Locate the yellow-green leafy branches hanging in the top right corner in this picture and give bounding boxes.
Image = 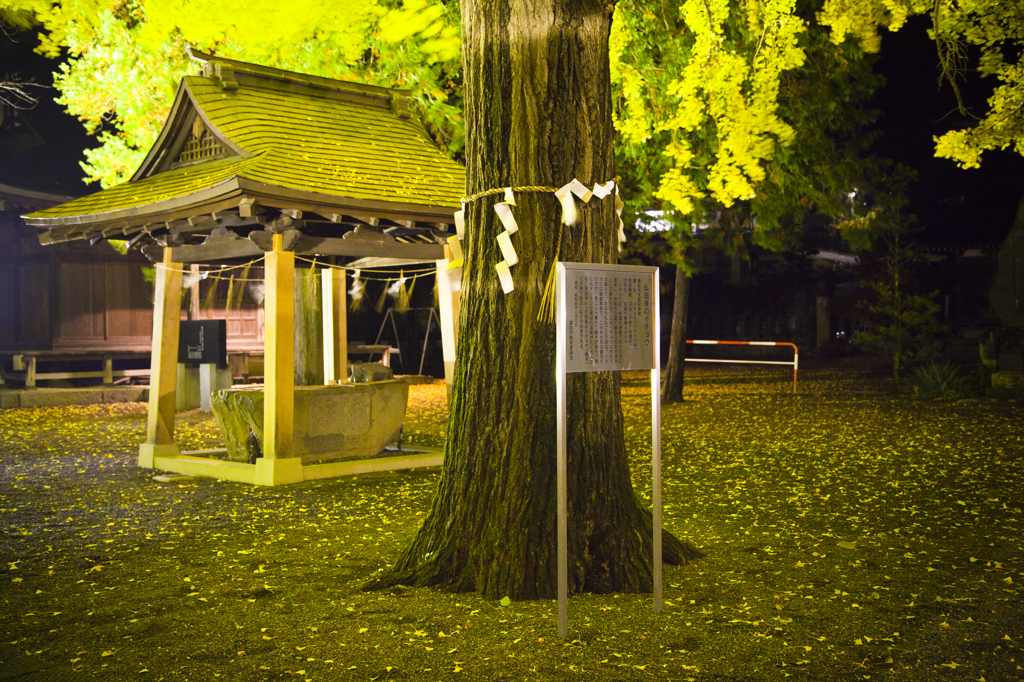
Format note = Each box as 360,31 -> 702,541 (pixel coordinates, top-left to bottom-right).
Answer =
821,0 -> 1024,168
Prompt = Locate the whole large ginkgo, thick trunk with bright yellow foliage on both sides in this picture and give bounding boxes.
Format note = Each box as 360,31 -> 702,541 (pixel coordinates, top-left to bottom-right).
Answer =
2,0 -> 1015,597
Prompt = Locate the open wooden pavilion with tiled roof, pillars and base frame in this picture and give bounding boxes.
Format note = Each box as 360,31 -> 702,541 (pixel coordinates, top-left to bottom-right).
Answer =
25,50 -> 465,485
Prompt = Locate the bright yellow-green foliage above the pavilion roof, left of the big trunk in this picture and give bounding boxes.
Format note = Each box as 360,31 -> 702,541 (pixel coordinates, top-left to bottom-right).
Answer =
0,0 -> 462,186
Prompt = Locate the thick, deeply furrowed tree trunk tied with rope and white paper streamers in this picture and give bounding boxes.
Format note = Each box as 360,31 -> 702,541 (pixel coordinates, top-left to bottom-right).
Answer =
378,0 -> 696,598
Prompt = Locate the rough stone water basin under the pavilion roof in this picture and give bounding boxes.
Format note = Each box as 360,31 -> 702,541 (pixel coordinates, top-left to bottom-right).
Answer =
211,379 -> 409,464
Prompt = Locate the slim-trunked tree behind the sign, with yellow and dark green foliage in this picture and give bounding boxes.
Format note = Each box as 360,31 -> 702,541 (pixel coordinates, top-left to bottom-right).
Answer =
611,0 -> 881,400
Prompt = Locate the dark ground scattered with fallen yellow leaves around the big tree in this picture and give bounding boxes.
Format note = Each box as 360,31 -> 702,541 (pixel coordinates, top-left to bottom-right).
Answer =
0,360 -> 1024,682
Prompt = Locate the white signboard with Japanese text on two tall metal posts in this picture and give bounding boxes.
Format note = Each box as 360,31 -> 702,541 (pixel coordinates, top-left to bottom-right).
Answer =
555,263 -> 662,639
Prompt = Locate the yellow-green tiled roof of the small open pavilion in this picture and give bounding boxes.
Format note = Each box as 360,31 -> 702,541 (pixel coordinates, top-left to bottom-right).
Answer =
27,53 -> 465,237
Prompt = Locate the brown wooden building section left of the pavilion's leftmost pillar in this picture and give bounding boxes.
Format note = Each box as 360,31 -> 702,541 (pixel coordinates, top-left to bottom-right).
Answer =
0,184 -> 153,387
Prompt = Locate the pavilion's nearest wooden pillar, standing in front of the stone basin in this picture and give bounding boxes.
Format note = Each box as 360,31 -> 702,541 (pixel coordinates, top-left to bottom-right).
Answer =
254,235 -> 302,485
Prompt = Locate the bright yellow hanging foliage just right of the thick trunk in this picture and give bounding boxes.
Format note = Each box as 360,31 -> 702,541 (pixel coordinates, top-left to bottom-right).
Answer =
611,0 -> 805,214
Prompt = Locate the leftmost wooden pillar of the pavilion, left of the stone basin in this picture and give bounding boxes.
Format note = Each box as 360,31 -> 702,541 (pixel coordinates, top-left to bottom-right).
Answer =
138,247 -> 181,469
